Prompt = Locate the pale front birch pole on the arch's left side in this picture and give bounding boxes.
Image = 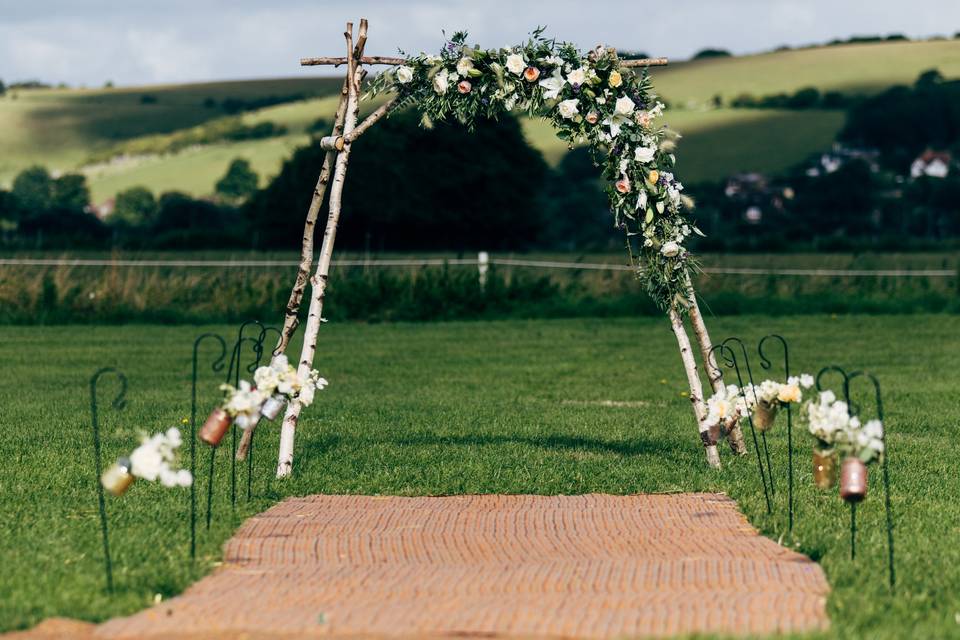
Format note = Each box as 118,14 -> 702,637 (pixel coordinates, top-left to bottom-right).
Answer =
277,20 -> 367,478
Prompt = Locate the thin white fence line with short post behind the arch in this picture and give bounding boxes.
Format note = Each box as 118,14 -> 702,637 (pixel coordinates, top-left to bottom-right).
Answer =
0,253 -> 958,278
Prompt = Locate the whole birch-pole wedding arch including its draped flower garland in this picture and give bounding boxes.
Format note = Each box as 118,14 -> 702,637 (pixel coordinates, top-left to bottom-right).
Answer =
237,19 -> 746,477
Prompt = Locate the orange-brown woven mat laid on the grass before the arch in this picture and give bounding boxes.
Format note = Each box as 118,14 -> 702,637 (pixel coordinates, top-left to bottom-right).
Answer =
86,494 -> 829,639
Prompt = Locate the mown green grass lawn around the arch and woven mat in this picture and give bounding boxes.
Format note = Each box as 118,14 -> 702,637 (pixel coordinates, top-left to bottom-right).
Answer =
0,315 -> 960,638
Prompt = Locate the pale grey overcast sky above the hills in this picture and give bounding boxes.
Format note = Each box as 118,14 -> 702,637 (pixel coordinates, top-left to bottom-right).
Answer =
0,0 -> 960,86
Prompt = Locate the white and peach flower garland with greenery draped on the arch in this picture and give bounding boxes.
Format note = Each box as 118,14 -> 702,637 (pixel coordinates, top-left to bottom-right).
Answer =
369,29 -> 702,310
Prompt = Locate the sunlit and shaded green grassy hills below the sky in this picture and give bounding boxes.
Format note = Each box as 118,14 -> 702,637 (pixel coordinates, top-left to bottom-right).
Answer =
0,40 -> 960,201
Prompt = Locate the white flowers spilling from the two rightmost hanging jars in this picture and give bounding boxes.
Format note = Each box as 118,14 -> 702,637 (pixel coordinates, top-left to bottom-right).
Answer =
804,390 -> 884,464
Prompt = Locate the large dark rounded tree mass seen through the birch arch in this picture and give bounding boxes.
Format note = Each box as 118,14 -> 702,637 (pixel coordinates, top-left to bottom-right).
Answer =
245,110 -> 548,251
